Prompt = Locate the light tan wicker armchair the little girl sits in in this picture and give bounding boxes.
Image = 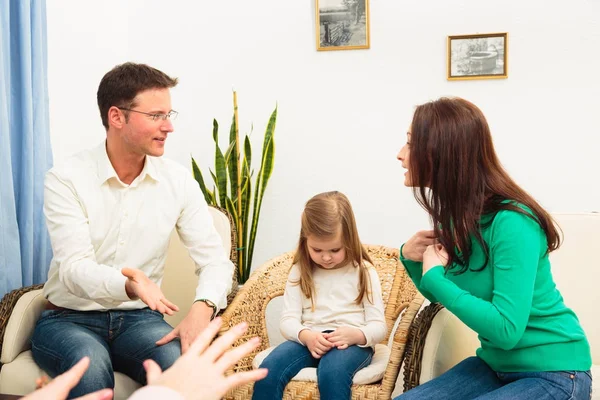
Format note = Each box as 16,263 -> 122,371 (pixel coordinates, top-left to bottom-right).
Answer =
221,246 -> 424,400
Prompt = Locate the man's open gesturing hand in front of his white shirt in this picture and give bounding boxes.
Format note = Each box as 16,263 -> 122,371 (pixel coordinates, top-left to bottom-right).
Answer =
121,268 -> 179,315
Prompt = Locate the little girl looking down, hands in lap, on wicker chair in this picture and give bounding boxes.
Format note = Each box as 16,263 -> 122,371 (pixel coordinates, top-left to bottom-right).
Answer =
252,192 -> 387,400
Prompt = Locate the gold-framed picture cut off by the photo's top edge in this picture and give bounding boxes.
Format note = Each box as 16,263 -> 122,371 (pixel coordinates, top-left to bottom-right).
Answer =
315,0 -> 369,51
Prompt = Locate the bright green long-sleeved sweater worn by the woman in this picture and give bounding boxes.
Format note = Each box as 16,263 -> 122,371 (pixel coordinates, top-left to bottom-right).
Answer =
400,210 -> 592,372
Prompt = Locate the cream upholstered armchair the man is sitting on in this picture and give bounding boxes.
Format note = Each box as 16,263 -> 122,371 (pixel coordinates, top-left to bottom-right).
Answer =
0,207 -> 237,400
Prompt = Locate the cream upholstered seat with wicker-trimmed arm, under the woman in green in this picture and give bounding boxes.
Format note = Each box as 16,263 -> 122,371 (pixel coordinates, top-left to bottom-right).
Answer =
393,213 -> 600,399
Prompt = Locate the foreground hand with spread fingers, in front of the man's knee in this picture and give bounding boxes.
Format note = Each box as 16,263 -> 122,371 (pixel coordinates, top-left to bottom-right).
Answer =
144,318 -> 267,400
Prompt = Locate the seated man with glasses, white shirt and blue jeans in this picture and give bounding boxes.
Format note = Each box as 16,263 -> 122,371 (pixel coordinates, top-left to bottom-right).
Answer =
32,63 -> 234,397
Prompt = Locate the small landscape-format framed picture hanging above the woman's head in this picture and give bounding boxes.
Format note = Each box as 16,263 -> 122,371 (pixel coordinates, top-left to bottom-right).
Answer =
448,33 -> 508,81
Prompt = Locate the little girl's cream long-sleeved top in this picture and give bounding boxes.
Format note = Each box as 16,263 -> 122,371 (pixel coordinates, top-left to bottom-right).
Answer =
279,263 -> 387,347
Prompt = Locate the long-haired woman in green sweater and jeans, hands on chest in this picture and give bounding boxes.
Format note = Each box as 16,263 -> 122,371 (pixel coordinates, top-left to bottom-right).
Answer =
398,98 -> 592,400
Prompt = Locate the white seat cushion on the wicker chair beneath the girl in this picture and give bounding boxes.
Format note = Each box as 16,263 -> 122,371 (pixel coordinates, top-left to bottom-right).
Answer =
252,344 -> 391,385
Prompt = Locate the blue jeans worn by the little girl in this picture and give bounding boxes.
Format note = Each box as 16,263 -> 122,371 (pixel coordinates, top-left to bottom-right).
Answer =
252,341 -> 373,400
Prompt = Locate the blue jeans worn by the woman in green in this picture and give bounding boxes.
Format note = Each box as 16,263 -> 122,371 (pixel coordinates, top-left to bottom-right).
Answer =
394,357 -> 592,400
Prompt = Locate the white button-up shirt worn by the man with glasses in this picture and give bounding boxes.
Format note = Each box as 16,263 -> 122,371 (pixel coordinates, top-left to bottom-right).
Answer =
44,142 -> 234,311
